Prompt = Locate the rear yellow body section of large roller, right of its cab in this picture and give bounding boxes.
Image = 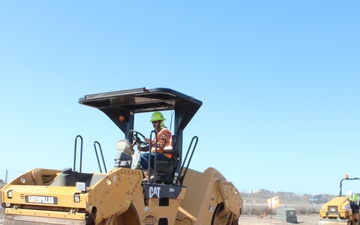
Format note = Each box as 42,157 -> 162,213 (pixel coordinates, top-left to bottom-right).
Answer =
179,168 -> 243,224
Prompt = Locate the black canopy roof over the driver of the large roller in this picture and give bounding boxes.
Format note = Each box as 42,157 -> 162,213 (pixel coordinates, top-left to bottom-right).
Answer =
79,88 -> 202,135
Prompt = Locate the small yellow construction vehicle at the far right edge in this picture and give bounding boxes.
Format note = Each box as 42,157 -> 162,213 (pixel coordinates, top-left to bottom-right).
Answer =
319,174 -> 360,225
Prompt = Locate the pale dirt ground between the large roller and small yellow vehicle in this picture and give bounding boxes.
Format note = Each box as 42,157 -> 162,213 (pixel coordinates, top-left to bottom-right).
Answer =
239,214 -> 320,225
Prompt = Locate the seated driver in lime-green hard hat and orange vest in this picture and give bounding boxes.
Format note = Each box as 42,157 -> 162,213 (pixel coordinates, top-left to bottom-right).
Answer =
137,112 -> 173,180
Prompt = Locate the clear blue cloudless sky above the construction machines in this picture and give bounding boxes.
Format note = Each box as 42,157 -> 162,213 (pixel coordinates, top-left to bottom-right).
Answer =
0,0 -> 360,194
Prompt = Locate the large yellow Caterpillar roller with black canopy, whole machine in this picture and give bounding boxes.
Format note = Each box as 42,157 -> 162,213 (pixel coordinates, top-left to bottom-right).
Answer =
1,88 -> 243,225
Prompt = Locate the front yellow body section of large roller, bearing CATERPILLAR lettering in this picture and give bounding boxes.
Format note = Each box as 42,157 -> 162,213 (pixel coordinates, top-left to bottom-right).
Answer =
1,168 -> 143,224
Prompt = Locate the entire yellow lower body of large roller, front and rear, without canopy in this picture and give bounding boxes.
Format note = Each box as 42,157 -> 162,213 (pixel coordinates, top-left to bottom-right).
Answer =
1,168 -> 242,225
